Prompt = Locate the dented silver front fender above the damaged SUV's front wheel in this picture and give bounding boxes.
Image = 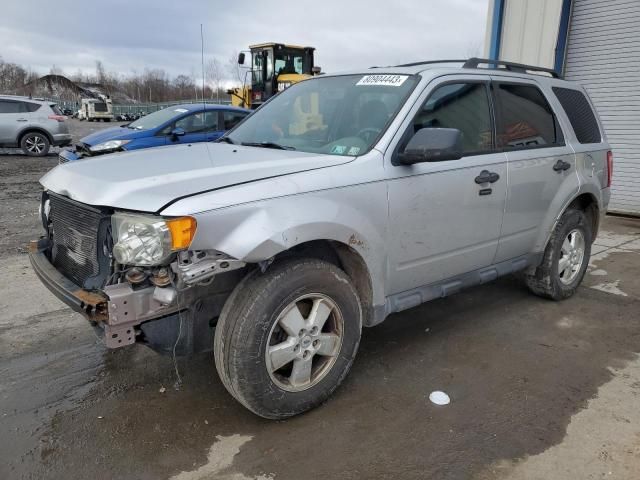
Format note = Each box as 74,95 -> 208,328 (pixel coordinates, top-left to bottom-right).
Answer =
191,182 -> 387,306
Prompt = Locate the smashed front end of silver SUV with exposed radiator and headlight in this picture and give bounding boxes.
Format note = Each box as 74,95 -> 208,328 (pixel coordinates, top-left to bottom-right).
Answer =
30,191 -> 245,353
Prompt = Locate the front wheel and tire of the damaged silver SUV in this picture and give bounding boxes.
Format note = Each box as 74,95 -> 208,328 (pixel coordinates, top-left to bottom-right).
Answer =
214,258 -> 362,419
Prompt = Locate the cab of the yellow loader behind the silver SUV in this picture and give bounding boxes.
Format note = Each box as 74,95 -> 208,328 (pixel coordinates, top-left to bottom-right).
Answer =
245,43 -> 319,108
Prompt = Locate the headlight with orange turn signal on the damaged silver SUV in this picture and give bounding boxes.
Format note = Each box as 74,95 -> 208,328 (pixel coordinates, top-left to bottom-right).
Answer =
111,213 -> 196,266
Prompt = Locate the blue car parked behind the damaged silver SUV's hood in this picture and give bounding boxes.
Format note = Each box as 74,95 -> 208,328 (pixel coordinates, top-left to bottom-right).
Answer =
58,103 -> 251,163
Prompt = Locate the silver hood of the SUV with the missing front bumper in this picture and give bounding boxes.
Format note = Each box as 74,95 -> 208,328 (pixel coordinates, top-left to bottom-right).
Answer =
40,143 -> 354,212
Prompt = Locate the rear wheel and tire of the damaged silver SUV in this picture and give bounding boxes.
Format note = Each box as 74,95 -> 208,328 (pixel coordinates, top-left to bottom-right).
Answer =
525,209 -> 593,300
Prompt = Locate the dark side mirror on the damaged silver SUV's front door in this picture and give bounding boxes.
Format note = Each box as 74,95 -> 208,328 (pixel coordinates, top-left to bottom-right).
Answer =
398,128 -> 462,165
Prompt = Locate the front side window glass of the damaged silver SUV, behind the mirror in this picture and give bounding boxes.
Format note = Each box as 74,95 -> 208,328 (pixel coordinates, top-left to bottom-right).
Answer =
413,82 -> 493,154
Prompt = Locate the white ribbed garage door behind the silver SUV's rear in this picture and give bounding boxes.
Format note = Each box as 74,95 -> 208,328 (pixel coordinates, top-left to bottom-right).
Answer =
565,0 -> 640,215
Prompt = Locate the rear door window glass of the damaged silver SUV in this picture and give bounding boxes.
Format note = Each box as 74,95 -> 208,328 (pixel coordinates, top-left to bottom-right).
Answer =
494,83 -> 564,150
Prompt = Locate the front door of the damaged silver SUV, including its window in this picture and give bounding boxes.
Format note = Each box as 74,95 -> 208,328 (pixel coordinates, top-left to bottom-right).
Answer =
387,77 -> 507,294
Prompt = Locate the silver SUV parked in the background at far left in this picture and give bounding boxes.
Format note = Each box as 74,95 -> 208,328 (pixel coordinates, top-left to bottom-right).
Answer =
0,95 -> 71,157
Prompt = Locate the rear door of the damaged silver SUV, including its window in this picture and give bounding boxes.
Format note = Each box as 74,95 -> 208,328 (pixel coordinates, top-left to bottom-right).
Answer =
492,76 -> 578,262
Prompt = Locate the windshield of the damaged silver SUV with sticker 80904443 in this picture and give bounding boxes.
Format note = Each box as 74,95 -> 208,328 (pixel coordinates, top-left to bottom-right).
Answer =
228,75 -> 419,156
